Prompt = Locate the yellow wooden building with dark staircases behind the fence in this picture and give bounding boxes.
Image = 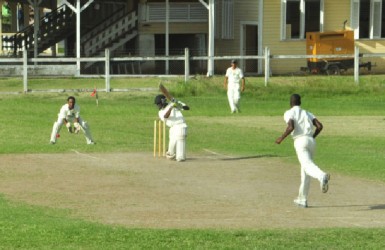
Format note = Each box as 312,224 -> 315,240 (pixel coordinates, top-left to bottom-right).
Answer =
0,0 -> 385,75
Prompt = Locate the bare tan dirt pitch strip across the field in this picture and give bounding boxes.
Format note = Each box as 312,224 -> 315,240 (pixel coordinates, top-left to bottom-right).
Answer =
0,150 -> 385,229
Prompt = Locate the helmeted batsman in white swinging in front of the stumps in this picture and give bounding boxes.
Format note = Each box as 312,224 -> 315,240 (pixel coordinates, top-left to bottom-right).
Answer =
155,95 -> 189,161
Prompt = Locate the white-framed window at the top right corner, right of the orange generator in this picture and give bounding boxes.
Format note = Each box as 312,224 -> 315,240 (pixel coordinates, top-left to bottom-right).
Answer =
351,0 -> 385,39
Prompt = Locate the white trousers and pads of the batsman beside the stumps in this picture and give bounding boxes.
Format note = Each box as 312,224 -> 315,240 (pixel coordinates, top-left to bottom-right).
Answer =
168,123 -> 187,161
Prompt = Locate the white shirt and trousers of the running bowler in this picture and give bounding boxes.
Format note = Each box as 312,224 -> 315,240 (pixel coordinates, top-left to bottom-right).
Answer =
284,106 -> 325,204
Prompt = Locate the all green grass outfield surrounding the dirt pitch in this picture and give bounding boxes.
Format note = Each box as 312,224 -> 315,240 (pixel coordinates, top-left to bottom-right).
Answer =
0,76 -> 385,249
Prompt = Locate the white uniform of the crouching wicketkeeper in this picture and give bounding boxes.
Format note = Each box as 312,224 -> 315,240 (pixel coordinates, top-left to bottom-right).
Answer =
50,103 -> 94,144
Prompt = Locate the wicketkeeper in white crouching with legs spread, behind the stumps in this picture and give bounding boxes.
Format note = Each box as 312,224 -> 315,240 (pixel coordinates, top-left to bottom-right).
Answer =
50,96 -> 95,145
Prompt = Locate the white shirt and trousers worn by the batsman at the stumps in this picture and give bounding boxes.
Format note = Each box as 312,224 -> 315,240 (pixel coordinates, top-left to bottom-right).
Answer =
158,103 -> 187,161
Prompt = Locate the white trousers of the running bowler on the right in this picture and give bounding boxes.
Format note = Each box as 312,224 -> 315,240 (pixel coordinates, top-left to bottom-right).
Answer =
294,136 -> 325,201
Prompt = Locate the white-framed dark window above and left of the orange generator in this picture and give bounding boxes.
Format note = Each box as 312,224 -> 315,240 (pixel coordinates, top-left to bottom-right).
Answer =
281,0 -> 324,40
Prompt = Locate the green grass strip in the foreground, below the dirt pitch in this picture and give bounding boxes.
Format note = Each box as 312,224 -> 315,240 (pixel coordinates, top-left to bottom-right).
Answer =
0,198 -> 385,249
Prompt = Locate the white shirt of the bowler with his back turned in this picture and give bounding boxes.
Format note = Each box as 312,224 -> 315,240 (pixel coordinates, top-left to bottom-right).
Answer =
284,106 -> 316,139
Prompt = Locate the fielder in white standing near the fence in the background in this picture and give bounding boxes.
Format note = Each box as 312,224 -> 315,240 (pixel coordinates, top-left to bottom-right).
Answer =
224,60 -> 245,113
